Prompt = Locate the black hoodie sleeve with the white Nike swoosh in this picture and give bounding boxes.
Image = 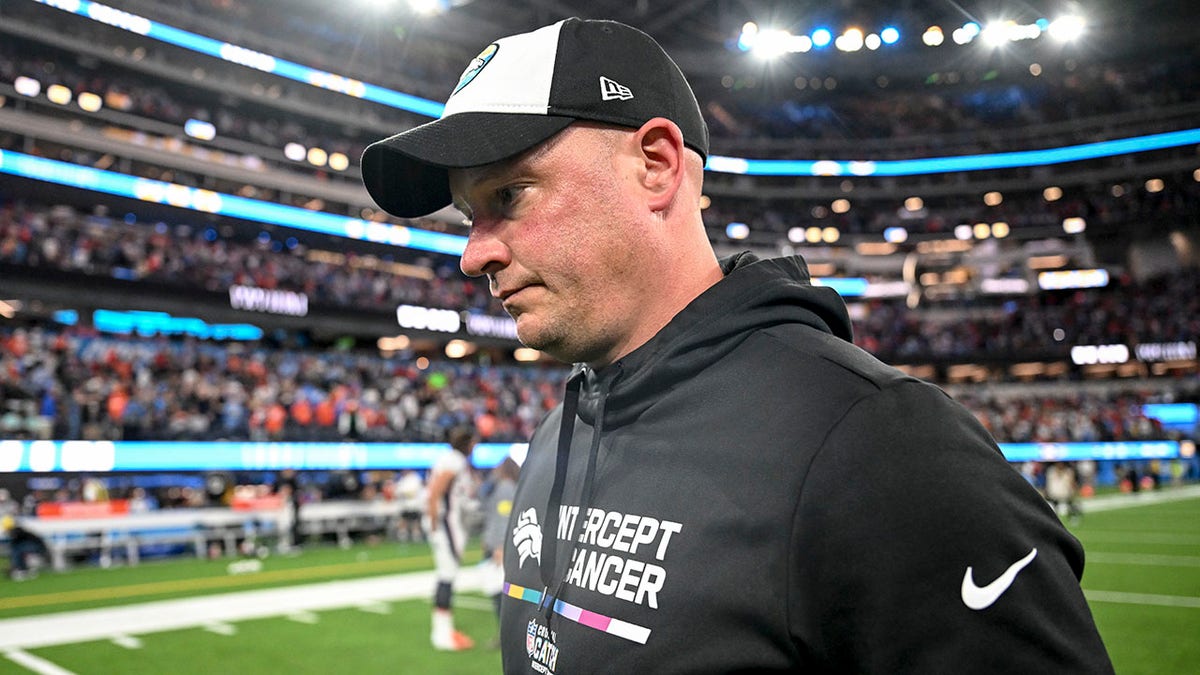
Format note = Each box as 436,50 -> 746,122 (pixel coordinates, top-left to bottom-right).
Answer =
790,381 -> 1112,674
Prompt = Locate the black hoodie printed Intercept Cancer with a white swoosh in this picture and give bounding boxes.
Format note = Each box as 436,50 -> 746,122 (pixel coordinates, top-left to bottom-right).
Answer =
502,253 -> 1111,675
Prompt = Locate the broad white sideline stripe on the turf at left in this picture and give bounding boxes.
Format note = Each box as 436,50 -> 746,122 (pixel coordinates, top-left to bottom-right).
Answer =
0,567 -> 481,653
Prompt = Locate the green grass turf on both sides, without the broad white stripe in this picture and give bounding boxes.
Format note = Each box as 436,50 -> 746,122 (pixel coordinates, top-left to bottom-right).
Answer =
0,487 -> 1200,675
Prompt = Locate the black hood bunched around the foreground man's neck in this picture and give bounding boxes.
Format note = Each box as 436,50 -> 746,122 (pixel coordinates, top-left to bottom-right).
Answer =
572,252 -> 853,429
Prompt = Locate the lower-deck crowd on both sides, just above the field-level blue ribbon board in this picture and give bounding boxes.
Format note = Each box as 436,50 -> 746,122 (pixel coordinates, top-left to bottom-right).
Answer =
0,327 -> 1200,442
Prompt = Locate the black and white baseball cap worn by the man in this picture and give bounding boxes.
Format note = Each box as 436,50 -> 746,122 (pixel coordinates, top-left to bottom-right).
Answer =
362,18 -> 708,217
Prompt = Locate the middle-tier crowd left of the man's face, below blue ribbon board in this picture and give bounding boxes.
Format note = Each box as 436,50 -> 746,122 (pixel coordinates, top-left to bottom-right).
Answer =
0,204 -> 503,313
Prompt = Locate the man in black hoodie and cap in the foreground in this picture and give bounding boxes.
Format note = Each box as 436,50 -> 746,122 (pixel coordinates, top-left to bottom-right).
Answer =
362,19 -> 1111,674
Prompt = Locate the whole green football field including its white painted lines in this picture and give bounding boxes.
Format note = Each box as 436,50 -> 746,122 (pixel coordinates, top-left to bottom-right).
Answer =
0,488 -> 1200,675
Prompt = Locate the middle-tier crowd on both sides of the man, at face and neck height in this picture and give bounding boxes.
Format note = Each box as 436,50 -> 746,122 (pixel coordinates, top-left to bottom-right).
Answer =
0,196 -> 1200,360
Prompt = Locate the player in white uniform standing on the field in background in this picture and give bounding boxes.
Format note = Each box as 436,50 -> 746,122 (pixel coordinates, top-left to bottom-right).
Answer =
425,428 -> 475,651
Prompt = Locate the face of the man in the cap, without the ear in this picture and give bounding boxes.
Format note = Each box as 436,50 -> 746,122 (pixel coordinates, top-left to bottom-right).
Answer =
450,126 -> 647,365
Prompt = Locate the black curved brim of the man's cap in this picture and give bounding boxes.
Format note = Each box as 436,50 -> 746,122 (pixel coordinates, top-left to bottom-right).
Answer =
361,113 -> 575,217
